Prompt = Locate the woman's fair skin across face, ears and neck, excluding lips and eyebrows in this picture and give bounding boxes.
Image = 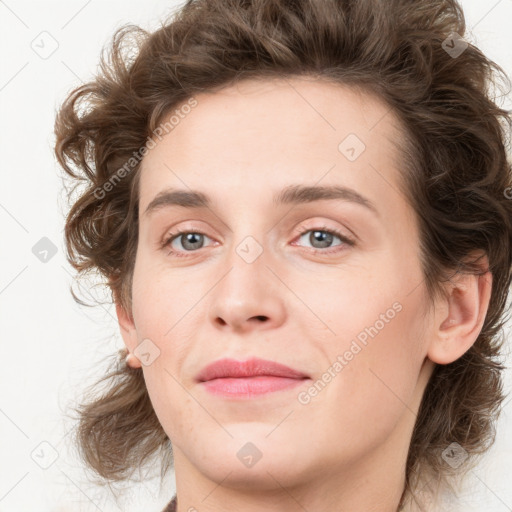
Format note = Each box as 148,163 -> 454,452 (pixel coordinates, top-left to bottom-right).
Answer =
117,78 -> 492,512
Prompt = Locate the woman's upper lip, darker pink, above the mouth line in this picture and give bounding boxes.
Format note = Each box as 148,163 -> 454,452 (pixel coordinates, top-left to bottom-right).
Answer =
196,357 -> 308,382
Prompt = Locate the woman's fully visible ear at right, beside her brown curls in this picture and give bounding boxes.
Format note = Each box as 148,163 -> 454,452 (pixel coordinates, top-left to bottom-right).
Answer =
427,254 -> 492,364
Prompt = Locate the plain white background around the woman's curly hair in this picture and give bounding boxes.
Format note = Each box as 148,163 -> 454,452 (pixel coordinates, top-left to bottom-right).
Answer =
0,0 -> 512,512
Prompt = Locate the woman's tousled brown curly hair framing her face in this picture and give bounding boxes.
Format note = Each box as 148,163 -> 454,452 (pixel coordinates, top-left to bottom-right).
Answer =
55,0 -> 512,503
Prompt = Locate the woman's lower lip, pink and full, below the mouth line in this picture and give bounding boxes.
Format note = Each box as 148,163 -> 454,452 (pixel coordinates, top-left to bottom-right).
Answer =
201,375 -> 309,398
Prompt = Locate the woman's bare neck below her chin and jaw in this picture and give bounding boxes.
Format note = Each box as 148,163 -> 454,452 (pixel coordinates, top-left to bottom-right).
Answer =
174,432 -> 408,512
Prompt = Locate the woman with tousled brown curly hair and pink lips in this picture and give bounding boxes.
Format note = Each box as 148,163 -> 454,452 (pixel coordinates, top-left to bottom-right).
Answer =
56,0 -> 512,512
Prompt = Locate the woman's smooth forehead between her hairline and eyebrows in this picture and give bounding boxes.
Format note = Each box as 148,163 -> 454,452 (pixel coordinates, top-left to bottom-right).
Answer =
140,78 -> 408,216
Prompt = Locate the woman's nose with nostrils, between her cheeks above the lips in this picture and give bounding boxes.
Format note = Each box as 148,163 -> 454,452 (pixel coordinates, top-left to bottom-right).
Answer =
209,243 -> 290,333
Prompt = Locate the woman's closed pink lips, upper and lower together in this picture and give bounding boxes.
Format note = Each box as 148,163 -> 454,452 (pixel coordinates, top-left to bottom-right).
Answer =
196,358 -> 309,397
